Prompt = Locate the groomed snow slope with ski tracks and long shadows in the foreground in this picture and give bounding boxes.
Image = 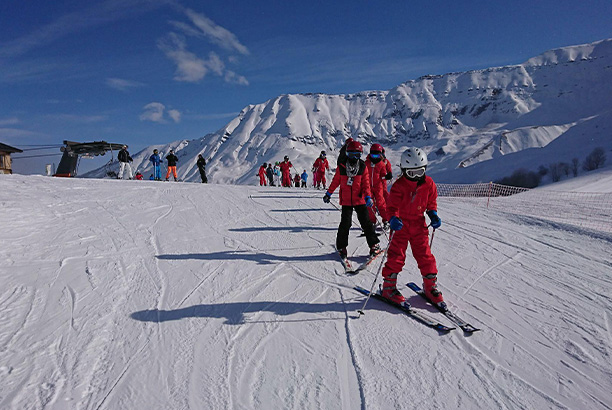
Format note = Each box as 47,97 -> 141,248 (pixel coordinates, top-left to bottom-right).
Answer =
0,175 -> 612,409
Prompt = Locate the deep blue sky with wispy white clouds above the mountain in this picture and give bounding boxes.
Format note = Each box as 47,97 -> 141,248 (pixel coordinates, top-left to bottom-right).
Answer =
0,0 -> 612,173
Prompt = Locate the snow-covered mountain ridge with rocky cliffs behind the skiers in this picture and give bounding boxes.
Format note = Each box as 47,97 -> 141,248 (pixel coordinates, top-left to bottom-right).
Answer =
85,39 -> 612,184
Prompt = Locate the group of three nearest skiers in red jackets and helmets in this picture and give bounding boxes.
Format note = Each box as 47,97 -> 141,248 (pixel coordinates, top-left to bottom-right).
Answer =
323,138 -> 443,304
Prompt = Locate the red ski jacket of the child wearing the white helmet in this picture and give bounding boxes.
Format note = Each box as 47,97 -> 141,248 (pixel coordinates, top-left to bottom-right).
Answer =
387,175 -> 438,223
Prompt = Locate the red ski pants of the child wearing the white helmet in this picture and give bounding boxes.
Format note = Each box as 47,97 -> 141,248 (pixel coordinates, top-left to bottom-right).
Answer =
382,217 -> 438,278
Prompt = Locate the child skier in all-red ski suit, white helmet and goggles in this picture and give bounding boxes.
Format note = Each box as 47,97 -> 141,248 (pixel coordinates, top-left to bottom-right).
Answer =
382,147 -> 444,304
